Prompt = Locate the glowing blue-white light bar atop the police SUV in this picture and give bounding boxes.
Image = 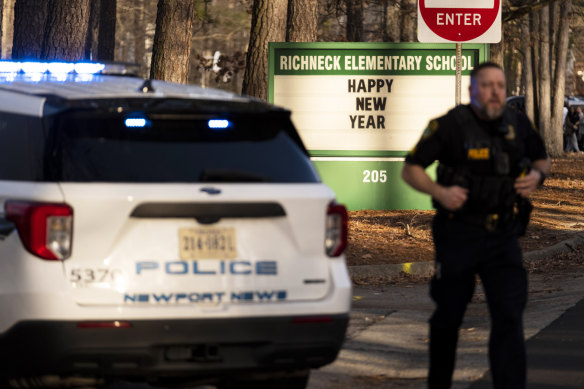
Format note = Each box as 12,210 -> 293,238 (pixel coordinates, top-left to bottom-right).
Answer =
0,61 -> 106,74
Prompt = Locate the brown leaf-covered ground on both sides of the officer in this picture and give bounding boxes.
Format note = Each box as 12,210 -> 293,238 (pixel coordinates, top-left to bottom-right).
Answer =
347,153 -> 584,271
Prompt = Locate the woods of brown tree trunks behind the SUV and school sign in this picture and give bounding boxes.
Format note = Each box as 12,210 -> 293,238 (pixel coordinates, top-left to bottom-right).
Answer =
0,0 -> 584,156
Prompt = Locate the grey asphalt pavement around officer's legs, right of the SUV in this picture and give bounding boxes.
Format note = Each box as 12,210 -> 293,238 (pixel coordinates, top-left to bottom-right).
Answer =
308,233 -> 584,389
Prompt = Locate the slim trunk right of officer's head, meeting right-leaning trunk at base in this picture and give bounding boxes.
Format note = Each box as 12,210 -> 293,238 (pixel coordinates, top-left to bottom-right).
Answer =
538,7 -> 562,156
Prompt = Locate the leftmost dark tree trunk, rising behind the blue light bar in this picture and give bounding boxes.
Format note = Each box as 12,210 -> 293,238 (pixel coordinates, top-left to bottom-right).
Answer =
12,0 -> 49,59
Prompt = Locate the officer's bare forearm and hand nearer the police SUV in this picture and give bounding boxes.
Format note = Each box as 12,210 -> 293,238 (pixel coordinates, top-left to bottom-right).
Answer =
402,162 -> 468,211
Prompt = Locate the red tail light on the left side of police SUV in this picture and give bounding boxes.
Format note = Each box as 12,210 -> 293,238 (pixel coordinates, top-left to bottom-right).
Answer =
4,201 -> 73,260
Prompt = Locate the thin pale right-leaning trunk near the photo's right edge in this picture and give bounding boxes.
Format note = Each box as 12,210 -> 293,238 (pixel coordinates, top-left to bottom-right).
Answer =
548,0 -> 572,157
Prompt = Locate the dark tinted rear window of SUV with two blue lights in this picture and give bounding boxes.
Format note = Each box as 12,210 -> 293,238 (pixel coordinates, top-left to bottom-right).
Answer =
46,103 -> 319,183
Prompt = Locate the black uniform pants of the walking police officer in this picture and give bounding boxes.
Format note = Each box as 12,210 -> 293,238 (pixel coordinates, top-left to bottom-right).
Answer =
428,216 -> 527,389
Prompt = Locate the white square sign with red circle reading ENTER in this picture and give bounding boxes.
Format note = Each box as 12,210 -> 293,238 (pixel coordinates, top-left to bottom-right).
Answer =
418,0 -> 501,43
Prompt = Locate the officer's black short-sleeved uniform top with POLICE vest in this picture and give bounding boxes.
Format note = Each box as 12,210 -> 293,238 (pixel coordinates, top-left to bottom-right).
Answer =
406,105 -> 547,218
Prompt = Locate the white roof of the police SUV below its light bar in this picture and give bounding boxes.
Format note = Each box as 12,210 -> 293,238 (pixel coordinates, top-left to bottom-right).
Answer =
0,73 -> 268,116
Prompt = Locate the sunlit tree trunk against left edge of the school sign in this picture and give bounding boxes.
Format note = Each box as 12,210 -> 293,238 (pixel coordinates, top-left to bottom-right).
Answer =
242,0 -> 288,100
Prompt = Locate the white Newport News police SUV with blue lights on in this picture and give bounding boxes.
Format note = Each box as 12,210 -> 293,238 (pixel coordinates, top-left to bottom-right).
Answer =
0,62 -> 351,388
